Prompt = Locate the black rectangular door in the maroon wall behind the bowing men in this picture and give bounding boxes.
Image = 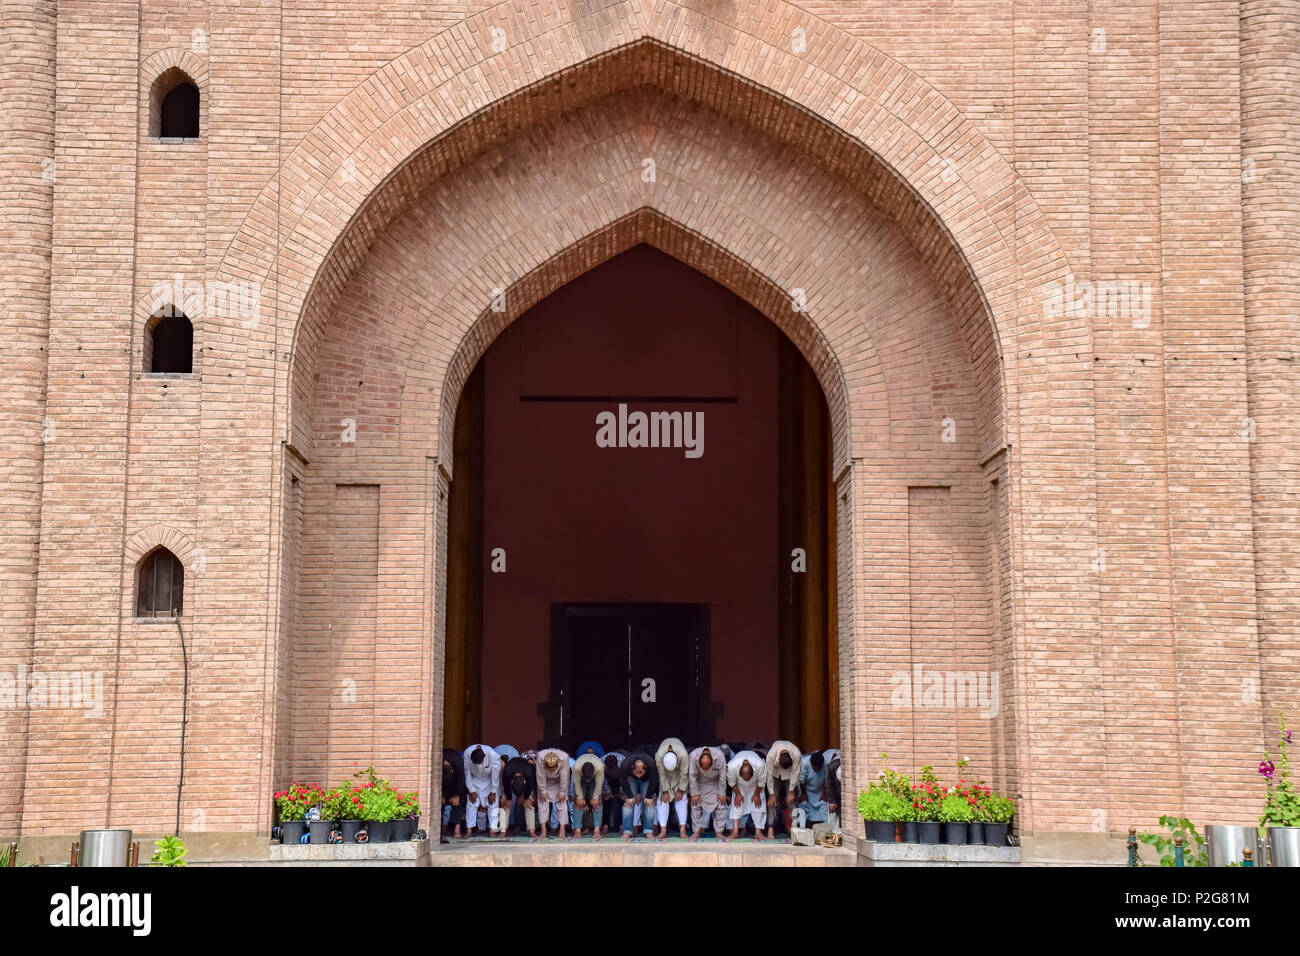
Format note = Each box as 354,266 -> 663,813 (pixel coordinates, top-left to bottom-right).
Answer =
543,604 -> 712,750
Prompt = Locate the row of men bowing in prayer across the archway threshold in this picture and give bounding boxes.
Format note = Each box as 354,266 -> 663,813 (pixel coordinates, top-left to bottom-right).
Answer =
442,737 -> 841,842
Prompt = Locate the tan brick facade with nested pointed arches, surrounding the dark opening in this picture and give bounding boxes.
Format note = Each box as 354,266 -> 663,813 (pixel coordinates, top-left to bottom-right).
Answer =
0,0 -> 1300,835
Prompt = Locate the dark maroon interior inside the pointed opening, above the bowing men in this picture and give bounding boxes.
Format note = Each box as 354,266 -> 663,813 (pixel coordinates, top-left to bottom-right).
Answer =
443,246 -> 839,750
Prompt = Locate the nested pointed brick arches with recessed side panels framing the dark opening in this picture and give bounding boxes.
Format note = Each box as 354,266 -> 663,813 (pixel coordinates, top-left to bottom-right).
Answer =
239,4 -> 1091,837
